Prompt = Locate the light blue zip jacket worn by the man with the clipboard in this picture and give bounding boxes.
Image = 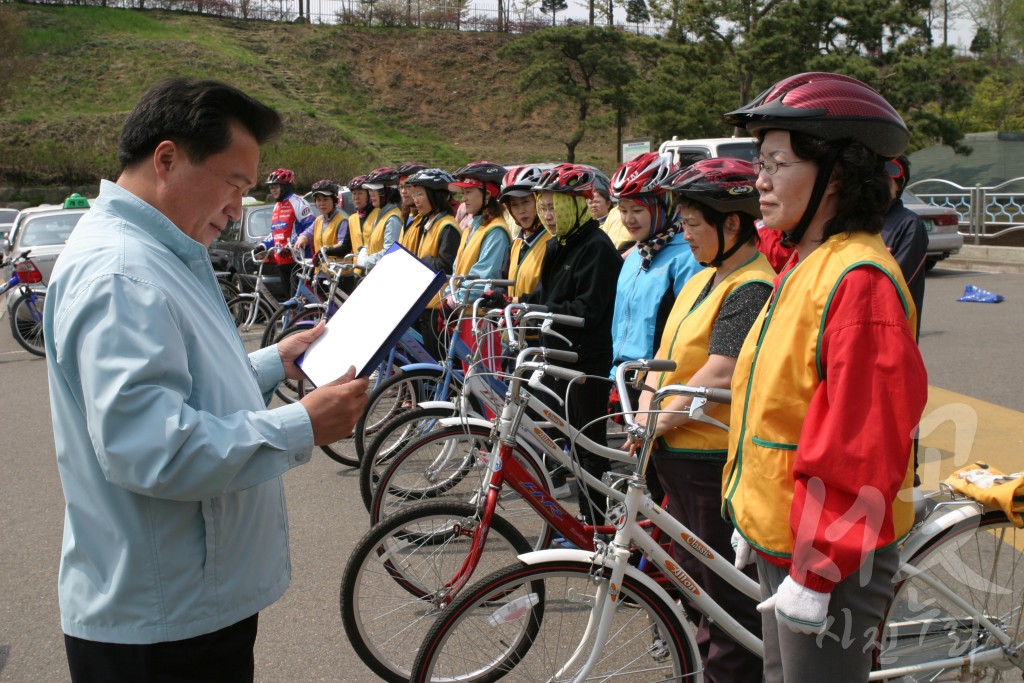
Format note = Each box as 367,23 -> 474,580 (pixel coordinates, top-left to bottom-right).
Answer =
44,182 -> 312,643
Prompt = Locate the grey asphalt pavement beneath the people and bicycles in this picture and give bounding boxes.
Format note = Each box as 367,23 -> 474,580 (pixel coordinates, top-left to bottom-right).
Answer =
0,268 -> 1024,683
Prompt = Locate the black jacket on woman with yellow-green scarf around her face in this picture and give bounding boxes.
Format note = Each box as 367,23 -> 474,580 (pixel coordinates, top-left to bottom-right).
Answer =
524,220 -> 623,375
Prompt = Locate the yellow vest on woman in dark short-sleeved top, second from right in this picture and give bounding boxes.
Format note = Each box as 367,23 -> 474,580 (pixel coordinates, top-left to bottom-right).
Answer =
655,252 -> 775,458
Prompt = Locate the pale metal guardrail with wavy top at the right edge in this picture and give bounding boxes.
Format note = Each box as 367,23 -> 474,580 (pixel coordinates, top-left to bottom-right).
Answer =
907,177 -> 1024,245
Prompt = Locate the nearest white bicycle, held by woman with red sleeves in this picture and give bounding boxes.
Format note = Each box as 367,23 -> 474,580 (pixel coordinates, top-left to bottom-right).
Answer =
411,361 -> 1024,681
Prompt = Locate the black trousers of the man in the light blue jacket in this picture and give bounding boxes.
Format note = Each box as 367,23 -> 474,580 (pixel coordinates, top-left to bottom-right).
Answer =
65,613 -> 259,683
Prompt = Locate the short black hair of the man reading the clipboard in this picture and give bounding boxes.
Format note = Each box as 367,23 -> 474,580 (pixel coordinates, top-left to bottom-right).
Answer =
118,78 -> 281,171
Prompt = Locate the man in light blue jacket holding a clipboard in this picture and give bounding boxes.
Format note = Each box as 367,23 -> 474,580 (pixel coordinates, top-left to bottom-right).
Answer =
44,79 -> 367,682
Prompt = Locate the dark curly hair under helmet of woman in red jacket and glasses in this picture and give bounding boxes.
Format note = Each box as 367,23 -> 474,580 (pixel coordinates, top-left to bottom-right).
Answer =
790,131 -> 891,240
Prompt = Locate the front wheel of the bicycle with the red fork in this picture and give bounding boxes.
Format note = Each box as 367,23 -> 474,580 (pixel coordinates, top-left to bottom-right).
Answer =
340,501 -> 530,683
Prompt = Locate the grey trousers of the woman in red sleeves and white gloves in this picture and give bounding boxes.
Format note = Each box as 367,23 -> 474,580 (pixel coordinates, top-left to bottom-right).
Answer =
757,547 -> 899,683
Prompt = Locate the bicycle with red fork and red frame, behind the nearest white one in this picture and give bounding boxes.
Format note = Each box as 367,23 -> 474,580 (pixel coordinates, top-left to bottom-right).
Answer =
340,349 -> 675,681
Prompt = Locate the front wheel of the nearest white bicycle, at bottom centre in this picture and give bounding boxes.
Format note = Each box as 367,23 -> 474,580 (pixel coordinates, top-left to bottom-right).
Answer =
410,560 -> 700,683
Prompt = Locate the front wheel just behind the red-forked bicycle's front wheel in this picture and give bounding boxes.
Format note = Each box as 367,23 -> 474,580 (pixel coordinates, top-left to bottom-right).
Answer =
370,425 -> 554,550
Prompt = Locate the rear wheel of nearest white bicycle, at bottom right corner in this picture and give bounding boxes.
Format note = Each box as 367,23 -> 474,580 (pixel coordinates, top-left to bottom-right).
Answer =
876,511 -> 1024,681
